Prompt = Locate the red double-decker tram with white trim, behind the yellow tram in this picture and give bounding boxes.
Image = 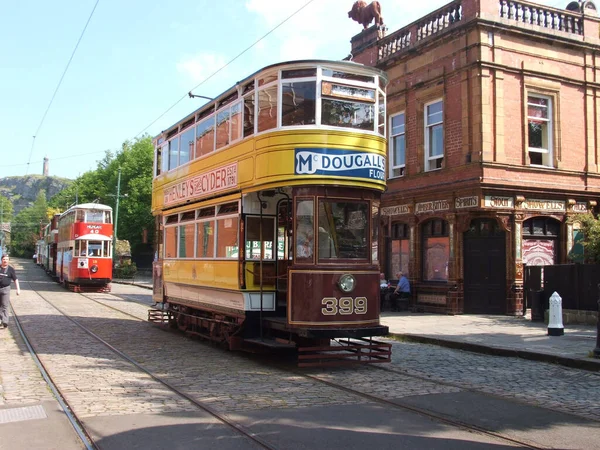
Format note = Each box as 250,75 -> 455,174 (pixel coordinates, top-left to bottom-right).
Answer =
56,203 -> 113,291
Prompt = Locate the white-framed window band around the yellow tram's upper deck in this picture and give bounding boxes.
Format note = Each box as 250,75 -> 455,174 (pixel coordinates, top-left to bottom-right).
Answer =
154,63 -> 388,177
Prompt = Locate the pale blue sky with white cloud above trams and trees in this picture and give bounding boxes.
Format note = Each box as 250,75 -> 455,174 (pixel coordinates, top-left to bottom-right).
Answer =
0,0 -> 569,179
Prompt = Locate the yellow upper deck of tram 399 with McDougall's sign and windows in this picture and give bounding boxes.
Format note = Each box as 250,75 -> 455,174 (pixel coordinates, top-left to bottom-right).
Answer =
152,60 -> 387,215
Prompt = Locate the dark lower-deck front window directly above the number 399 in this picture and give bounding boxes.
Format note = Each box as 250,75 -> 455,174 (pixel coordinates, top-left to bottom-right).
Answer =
318,200 -> 369,260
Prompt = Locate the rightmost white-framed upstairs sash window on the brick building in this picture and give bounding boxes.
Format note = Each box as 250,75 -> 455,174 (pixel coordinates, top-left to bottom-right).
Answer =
527,95 -> 553,167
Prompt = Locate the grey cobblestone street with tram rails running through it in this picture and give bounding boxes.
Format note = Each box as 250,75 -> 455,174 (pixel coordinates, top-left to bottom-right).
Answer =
0,272 -> 600,448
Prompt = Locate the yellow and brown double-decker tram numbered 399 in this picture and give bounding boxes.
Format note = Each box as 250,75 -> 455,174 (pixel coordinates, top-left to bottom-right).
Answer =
149,60 -> 391,365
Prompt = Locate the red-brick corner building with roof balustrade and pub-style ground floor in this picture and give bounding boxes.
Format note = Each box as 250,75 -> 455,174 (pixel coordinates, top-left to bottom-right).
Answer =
352,0 -> 600,315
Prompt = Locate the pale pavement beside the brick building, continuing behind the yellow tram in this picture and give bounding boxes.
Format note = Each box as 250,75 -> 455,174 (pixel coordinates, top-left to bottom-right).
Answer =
115,275 -> 600,371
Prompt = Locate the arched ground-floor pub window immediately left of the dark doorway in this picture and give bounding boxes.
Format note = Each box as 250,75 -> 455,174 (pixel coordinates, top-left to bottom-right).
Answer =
422,219 -> 450,281
